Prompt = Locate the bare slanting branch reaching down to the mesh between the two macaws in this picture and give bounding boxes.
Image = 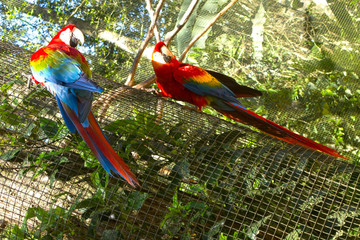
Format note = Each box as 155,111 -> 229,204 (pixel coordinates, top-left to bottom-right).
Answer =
125,0 -> 165,86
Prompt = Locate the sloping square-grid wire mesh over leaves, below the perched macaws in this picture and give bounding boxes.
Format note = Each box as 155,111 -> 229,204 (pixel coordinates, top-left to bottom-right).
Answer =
0,39 -> 360,239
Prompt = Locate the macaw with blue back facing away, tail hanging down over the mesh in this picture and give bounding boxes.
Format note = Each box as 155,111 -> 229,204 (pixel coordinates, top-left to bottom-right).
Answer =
30,25 -> 139,186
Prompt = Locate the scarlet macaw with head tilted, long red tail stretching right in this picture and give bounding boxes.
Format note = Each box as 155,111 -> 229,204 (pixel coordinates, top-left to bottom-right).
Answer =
152,42 -> 345,158
